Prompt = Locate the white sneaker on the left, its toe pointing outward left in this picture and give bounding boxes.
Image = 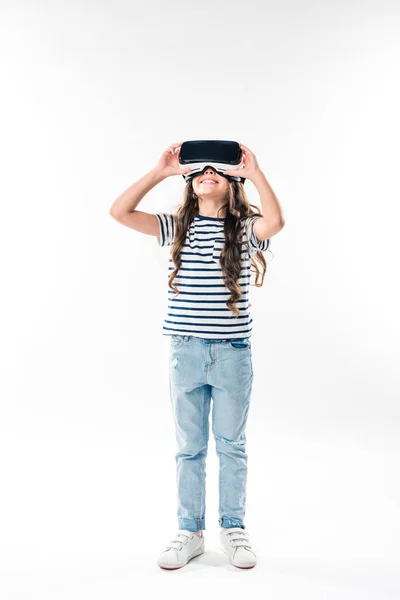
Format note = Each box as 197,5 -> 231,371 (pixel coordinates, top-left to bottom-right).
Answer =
157,529 -> 204,569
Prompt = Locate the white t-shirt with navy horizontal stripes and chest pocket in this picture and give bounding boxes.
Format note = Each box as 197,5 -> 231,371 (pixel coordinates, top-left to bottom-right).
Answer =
156,213 -> 270,339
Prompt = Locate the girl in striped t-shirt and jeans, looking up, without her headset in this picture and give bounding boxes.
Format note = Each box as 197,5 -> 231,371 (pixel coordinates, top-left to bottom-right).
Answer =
110,143 -> 284,569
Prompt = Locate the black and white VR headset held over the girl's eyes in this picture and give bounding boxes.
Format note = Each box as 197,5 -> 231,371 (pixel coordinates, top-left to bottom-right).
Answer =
179,140 -> 246,183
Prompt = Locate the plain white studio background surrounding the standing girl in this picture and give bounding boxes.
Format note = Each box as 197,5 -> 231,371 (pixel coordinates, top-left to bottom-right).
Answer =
0,0 -> 400,600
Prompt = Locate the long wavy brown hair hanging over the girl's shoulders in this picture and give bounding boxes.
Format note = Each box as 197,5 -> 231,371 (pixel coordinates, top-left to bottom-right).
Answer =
168,180 -> 267,318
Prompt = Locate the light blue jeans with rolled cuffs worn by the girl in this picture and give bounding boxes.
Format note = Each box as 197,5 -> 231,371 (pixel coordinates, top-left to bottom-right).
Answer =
169,335 -> 253,531
